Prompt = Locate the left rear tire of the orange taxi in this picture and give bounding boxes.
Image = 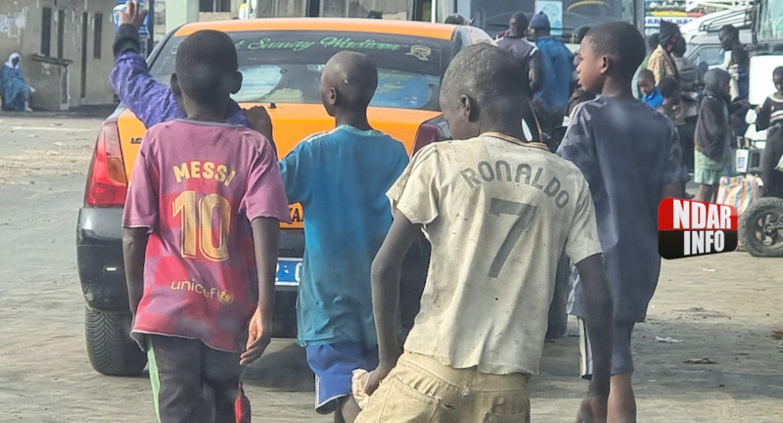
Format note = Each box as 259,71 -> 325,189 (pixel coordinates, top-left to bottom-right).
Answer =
84,308 -> 147,376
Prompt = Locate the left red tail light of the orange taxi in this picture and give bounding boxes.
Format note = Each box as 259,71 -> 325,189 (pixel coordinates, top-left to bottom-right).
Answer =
84,120 -> 128,207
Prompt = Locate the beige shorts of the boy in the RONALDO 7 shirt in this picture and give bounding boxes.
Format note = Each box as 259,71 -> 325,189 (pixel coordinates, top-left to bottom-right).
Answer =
356,352 -> 530,423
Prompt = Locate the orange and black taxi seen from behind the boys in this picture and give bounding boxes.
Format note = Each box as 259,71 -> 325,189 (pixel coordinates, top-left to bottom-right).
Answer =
77,18 -> 493,375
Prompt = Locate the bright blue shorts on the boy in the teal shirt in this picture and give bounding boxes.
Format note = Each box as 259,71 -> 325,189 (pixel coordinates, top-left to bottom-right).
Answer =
305,342 -> 378,414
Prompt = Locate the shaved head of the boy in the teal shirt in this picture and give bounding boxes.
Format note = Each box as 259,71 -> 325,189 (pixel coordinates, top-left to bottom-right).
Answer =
321,51 -> 378,114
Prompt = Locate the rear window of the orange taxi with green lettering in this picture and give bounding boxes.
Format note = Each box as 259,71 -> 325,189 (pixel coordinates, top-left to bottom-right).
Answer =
150,31 -> 451,110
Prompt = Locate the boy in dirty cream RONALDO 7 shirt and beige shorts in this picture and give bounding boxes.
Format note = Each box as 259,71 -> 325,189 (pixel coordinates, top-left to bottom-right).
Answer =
357,44 -> 611,423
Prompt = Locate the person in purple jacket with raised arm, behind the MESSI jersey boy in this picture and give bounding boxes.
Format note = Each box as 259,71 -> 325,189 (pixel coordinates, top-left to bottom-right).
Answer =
110,0 -> 277,423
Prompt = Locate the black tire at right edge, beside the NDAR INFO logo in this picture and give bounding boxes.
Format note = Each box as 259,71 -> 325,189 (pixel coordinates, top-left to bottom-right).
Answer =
739,197 -> 783,257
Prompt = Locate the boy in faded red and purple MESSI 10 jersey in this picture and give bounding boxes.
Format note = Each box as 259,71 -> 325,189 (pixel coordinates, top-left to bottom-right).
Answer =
123,31 -> 289,423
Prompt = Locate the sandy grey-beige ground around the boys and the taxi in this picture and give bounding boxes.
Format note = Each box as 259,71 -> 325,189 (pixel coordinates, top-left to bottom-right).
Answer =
0,114 -> 783,423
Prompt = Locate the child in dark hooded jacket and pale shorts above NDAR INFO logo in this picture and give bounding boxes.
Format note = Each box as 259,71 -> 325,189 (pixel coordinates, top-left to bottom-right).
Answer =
693,69 -> 731,202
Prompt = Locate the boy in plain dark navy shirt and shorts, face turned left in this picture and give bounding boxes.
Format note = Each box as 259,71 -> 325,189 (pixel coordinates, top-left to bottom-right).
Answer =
558,22 -> 688,422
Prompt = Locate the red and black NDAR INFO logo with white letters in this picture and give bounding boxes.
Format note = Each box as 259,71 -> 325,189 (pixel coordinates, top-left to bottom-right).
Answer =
658,198 -> 738,259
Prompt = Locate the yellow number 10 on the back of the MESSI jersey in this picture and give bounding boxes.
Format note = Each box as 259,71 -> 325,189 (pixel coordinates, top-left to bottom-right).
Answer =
172,191 -> 231,261
